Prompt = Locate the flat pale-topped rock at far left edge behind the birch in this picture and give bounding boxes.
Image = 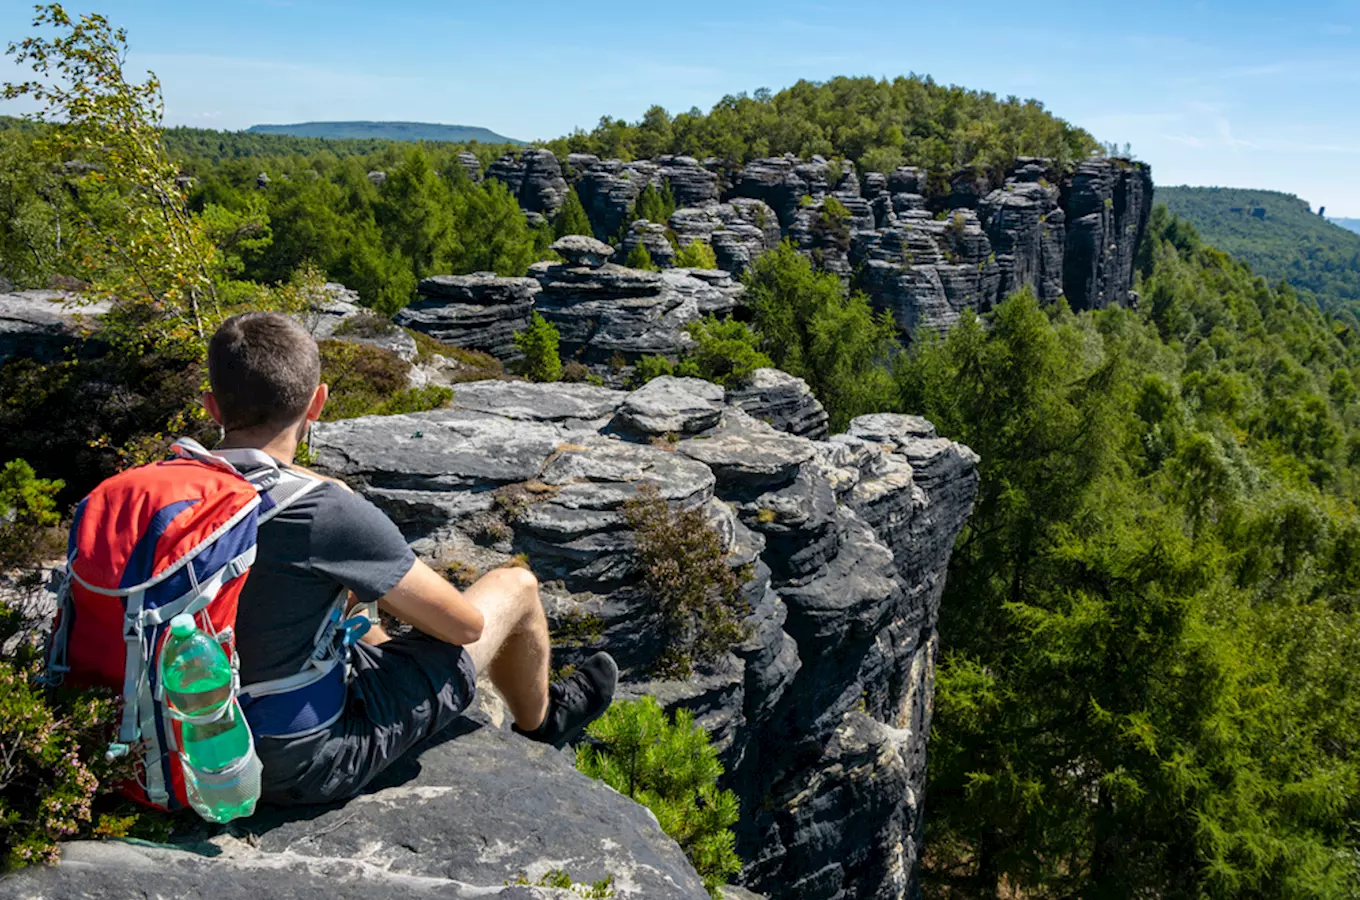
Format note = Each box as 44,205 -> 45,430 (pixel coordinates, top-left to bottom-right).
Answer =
0,291 -> 109,363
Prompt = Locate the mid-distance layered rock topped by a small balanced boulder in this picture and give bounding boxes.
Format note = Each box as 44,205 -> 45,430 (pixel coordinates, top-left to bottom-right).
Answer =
530,247 -> 744,364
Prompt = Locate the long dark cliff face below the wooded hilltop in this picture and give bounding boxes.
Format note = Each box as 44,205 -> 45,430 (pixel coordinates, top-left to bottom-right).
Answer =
487,151 -> 1152,333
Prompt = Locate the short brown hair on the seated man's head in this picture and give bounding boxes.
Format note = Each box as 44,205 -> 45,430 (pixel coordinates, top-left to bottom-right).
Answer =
208,313 -> 321,430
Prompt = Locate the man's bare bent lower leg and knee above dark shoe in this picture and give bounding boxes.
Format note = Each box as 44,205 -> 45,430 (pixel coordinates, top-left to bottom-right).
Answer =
462,568 -> 552,731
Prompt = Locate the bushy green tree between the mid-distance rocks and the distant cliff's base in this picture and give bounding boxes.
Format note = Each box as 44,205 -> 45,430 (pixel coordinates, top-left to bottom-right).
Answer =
745,241 -> 899,431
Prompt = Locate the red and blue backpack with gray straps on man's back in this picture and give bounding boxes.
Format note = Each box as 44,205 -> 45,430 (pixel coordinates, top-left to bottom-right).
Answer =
48,439 -> 363,810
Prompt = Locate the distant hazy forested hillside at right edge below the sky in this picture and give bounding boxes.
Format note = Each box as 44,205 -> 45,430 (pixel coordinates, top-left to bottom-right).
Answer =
1156,188 -> 1360,314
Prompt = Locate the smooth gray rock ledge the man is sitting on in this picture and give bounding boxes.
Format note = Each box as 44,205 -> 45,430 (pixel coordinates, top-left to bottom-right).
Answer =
0,718 -> 707,900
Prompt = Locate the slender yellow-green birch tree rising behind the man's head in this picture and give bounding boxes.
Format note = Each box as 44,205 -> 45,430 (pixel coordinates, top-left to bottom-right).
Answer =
0,4 -> 304,355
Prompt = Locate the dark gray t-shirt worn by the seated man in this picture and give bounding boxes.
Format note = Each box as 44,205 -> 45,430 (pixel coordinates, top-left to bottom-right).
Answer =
237,481 -> 416,685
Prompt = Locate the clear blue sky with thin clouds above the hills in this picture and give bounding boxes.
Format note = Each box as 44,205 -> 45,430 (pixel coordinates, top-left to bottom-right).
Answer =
0,0 -> 1360,216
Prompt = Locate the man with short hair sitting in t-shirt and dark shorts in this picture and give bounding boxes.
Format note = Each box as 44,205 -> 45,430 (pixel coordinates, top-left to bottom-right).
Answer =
204,313 -> 619,803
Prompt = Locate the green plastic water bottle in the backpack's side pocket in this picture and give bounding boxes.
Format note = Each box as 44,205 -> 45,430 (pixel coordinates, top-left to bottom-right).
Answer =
160,613 -> 260,823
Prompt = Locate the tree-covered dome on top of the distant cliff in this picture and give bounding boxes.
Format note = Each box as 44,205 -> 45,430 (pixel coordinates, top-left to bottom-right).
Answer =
548,76 -> 1100,188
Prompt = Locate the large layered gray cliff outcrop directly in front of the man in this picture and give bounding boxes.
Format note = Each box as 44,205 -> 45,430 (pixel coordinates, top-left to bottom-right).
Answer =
306,380 -> 976,899
